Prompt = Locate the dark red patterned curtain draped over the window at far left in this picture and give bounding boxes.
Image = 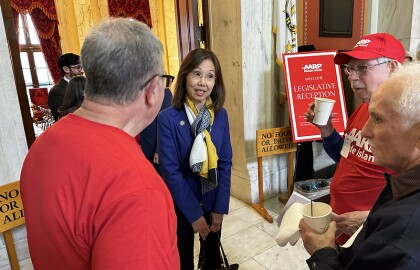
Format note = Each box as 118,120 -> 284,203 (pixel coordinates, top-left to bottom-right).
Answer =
10,0 -> 63,83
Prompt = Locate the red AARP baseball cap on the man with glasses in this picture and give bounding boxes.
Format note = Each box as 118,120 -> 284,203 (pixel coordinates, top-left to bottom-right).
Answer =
334,33 -> 405,65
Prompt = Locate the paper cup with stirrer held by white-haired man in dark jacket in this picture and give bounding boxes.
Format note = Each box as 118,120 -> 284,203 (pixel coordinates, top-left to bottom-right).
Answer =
301,202 -> 331,233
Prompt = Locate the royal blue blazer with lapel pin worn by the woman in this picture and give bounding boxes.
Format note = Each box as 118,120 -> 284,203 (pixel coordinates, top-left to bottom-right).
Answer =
158,107 -> 232,223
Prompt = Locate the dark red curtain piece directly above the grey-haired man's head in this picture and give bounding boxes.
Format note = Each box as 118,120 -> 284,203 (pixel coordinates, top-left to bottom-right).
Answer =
108,0 -> 152,28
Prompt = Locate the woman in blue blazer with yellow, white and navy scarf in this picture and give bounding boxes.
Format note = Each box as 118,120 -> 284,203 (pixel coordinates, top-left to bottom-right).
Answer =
158,48 -> 232,270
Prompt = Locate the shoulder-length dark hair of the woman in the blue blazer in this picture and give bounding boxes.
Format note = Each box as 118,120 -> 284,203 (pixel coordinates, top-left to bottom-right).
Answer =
172,48 -> 226,114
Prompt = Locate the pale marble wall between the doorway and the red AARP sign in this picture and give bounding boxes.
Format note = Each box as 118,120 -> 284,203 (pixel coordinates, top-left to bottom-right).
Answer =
241,0 -> 288,202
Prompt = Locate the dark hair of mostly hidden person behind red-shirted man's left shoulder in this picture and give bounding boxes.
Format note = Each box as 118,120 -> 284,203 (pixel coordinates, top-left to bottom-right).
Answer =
59,75 -> 86,116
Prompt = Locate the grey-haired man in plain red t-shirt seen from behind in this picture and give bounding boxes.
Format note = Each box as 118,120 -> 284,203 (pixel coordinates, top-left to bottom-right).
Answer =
21,18 -> 180,270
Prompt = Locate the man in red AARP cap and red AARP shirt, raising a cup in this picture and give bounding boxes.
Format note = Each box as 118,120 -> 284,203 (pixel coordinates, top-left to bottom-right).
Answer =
306,33 -> 405,245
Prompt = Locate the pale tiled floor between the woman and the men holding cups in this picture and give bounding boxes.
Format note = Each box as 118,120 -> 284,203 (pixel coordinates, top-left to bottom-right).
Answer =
195,197 -> 309,270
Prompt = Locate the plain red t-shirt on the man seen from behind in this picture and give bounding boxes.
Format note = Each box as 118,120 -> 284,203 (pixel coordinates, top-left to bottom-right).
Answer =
21,114 -> 180,270
